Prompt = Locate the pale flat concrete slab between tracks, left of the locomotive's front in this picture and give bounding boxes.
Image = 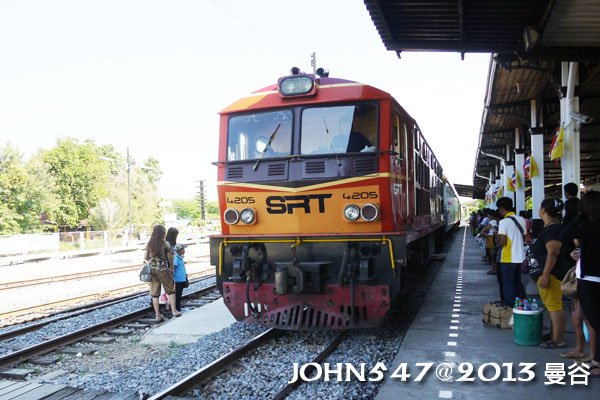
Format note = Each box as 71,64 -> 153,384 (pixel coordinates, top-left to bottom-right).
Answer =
141,298 -> 235,345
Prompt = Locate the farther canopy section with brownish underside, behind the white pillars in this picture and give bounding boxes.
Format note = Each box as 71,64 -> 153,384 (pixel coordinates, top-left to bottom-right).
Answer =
473,59 -> 600,198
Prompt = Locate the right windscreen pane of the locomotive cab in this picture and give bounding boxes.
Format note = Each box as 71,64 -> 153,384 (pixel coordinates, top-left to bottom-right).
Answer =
300,104 -> 378,155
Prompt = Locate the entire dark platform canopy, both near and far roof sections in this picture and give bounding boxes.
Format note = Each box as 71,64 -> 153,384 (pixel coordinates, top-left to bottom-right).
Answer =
365,0 -> 600,199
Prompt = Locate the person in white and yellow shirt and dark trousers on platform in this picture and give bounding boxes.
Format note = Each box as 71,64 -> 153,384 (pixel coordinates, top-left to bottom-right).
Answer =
496,197 -> 527,307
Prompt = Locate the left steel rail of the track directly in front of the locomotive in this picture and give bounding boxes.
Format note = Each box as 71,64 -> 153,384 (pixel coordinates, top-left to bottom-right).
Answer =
147,328 -> 285,400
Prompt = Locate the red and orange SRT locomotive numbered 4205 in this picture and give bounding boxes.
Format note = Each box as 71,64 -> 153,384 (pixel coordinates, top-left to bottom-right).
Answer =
210,69 -> 459,330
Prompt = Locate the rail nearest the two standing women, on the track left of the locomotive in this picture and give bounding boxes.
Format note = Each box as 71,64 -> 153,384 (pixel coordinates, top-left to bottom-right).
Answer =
0,284 -> 216,369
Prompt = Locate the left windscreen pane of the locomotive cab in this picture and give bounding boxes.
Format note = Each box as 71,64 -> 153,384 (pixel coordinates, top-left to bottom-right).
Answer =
227,110 -> 292,161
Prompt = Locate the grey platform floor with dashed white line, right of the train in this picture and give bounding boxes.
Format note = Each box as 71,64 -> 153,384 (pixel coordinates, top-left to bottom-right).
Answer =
376,229 -> 600,400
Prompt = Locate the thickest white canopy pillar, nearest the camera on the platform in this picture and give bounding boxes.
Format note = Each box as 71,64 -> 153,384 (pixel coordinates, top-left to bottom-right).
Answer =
560,62 -> 581,197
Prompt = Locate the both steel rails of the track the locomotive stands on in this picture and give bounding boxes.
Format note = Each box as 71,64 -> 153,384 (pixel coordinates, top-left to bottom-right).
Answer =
148,328 -> 347,400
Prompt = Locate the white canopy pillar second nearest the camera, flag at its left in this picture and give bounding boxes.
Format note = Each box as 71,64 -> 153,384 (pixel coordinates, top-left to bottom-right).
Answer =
530,100 -> 545,225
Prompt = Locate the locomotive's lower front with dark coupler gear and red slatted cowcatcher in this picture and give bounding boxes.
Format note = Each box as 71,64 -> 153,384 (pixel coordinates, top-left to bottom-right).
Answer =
211,233 -> 450,330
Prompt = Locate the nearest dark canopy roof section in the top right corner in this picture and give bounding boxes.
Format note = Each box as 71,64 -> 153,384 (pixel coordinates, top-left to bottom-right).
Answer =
365,0 -> 600,61
